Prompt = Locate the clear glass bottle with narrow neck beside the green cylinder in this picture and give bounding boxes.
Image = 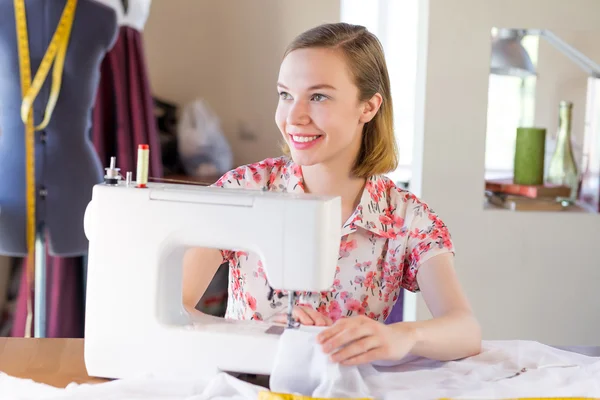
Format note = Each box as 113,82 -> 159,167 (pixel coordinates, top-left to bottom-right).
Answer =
546,100 -> 579,201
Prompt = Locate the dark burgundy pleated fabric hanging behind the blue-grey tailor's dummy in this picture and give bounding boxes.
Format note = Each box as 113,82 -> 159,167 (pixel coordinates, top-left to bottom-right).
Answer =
11,26 -> 163,338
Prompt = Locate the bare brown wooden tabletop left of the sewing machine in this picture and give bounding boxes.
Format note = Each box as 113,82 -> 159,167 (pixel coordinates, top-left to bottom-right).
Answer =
0,338 -> 107,388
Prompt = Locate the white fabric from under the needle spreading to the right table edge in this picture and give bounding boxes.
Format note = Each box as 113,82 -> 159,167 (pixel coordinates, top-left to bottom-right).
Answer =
270,331 -> 600,400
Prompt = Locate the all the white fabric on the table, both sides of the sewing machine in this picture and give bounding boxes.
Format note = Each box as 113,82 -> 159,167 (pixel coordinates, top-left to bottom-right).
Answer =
0,330 -> 600,400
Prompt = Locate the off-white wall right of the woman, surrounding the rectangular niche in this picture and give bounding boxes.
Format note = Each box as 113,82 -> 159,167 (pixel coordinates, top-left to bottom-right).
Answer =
412,0 -> 600,345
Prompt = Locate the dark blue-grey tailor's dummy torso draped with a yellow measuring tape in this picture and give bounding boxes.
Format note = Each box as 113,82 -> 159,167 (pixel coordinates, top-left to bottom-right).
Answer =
0,0 -> 118,257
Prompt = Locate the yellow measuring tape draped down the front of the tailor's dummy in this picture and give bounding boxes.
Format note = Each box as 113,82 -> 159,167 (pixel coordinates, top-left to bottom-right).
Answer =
14,0 -> 77,337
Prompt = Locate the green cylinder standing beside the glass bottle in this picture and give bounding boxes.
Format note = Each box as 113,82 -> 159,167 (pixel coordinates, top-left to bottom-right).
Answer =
513,127 -> 546,185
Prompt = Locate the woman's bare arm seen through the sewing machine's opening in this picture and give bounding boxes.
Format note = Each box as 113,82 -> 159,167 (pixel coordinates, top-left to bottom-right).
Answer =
183,248 -> 223,312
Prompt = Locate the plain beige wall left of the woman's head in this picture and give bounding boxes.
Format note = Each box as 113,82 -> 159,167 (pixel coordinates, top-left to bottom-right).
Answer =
139,0 -> 340,165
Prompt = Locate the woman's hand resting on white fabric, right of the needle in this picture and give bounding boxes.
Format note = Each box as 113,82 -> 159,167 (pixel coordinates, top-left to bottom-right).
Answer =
317,315 -> 417,365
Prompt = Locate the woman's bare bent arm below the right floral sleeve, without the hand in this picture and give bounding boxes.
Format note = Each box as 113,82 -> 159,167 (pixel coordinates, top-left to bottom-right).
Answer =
390,253 -> 481,361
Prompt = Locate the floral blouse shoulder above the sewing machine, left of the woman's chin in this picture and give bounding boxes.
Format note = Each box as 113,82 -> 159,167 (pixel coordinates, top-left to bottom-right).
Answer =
213,156 -> 296,190
